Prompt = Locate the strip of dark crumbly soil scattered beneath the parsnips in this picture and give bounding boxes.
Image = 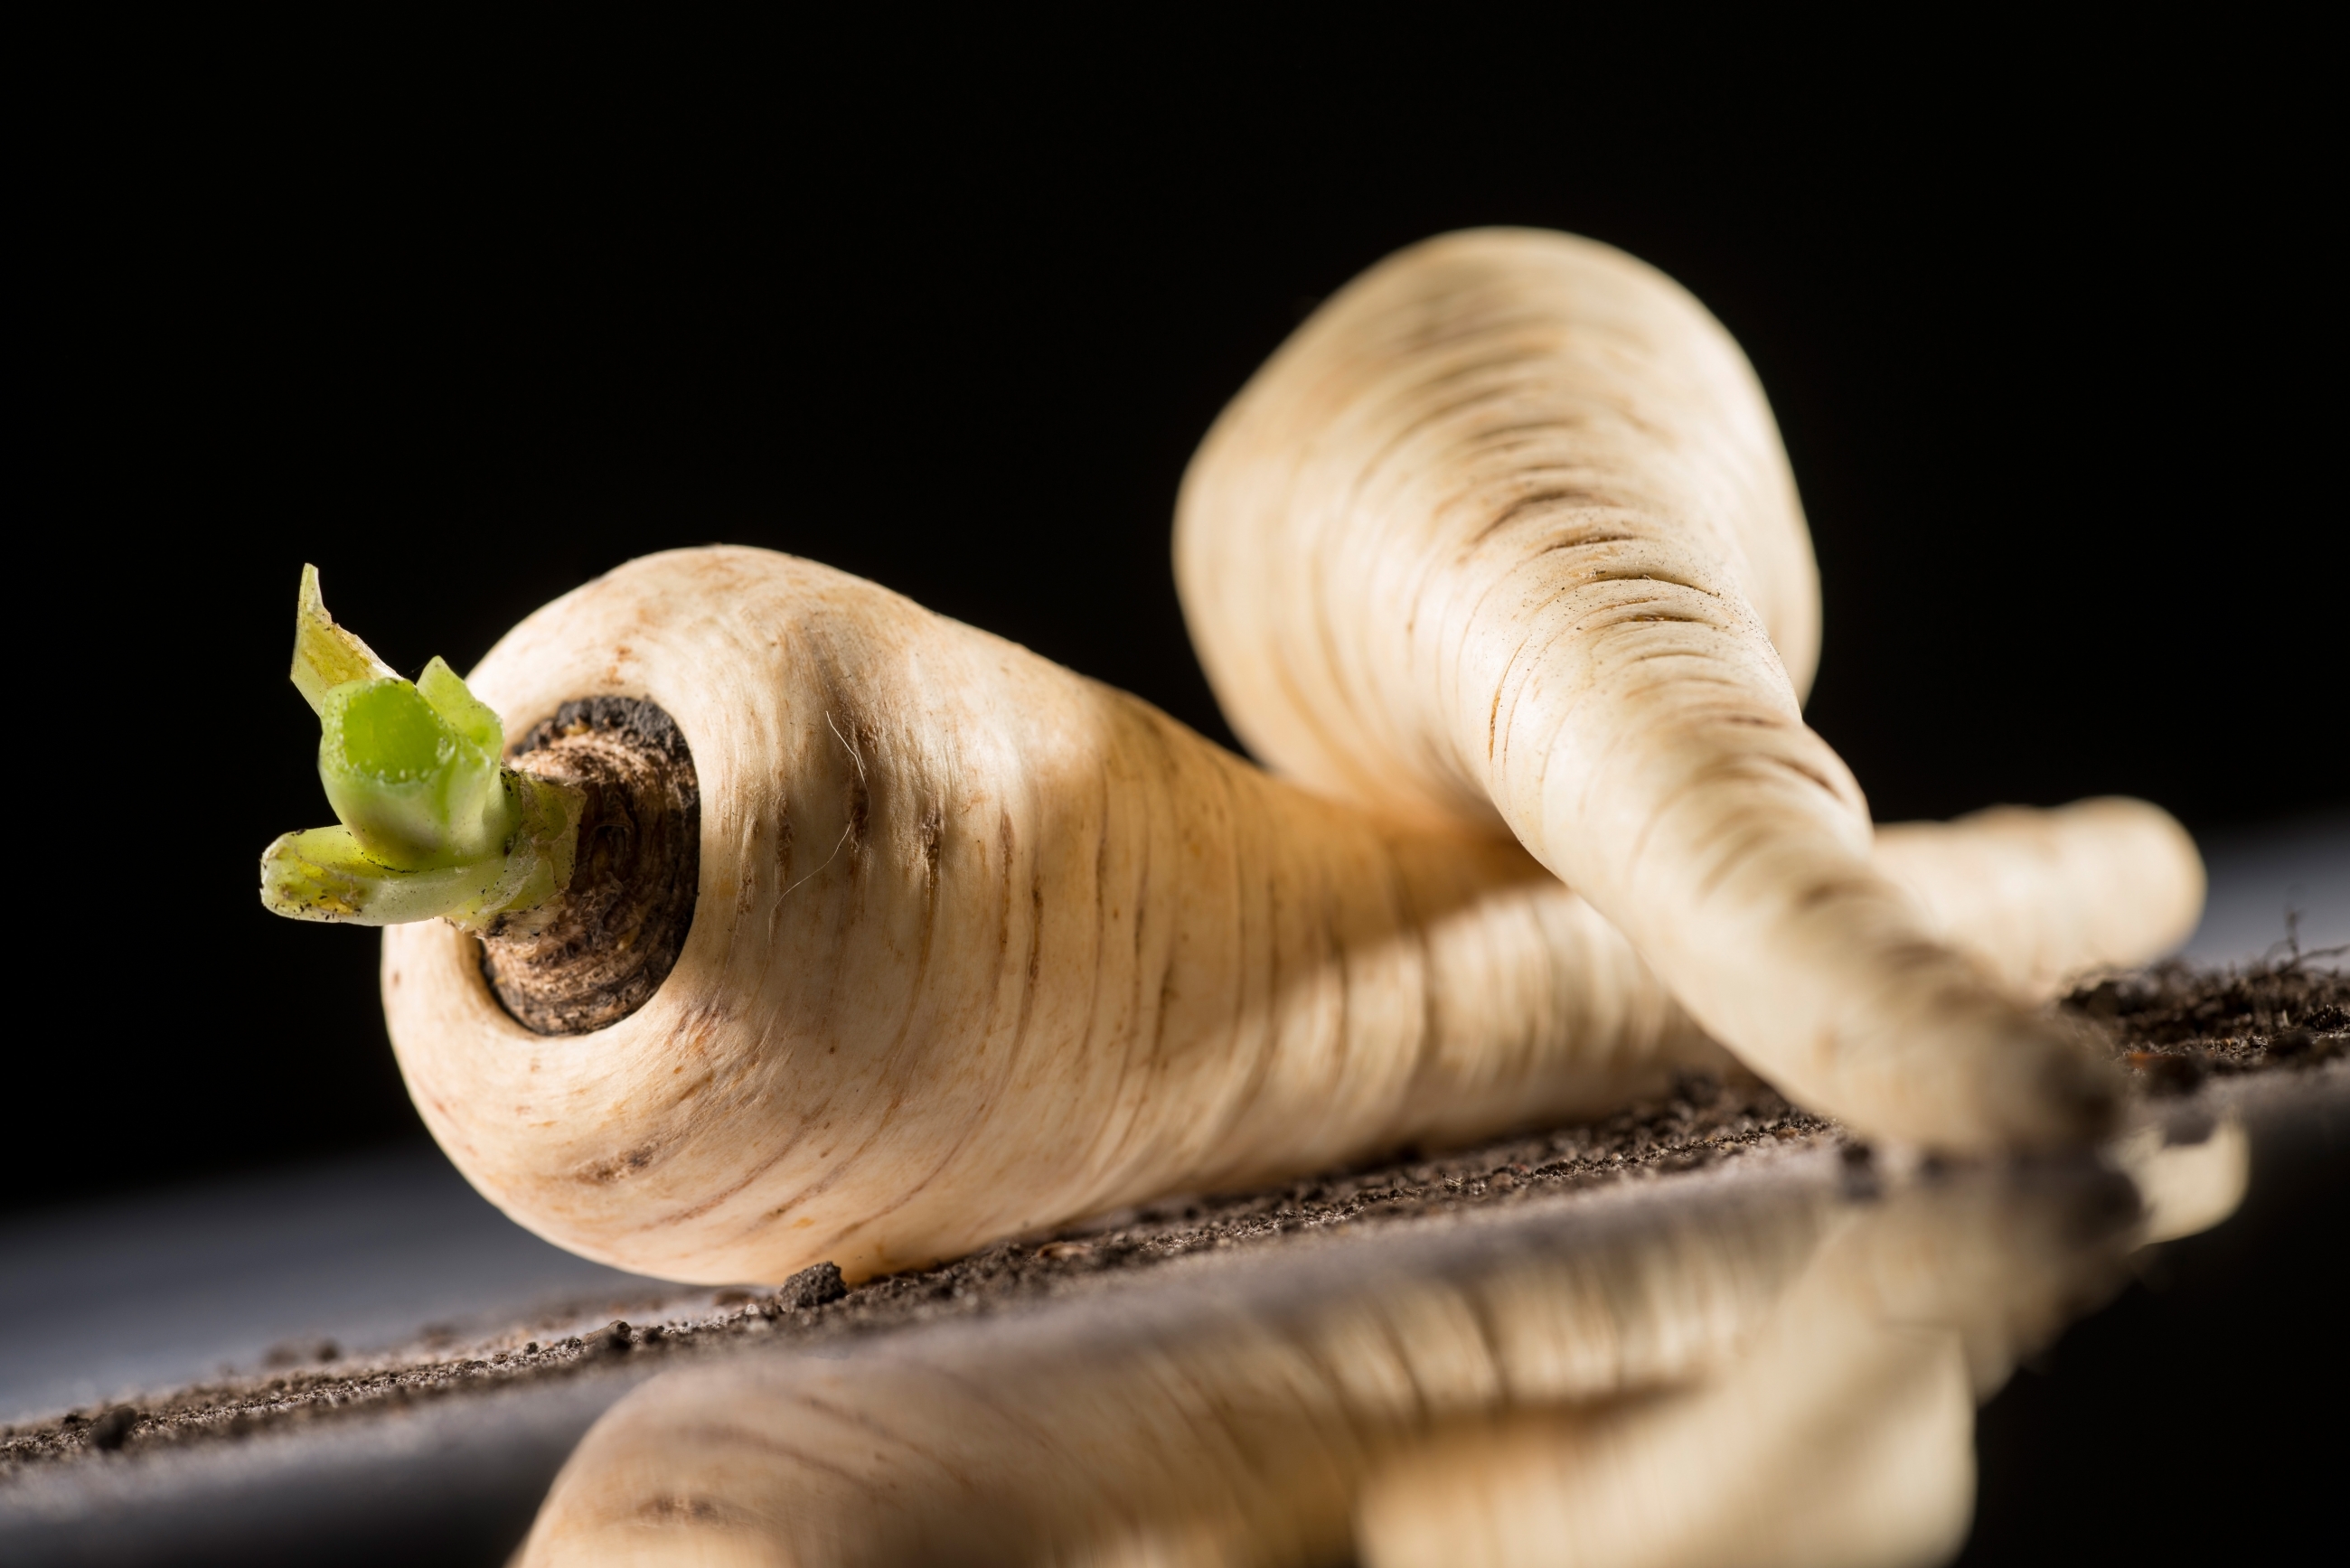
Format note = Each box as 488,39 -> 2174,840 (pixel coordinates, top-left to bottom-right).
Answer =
0,962 -> 2350,1481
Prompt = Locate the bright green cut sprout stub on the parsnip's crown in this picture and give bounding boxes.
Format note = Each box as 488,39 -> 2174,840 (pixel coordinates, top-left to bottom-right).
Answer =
261,567 -> 580,931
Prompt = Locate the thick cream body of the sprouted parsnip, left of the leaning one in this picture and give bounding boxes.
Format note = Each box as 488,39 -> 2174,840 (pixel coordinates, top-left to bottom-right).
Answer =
383,548 -> 1727,1282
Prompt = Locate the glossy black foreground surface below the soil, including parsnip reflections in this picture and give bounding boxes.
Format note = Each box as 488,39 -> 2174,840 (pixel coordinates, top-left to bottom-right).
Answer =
14,1063 -> 2350,1563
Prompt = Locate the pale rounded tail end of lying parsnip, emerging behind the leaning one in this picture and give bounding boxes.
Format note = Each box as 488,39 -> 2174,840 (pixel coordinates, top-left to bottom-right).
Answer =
1875,797 -> 2204,1001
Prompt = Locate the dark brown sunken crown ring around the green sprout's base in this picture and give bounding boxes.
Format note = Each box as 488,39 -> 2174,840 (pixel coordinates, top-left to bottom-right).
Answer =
482,696 -> 702,1035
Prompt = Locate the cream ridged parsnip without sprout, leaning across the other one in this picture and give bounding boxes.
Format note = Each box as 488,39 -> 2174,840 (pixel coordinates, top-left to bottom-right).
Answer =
1175,230 -> 2162,1150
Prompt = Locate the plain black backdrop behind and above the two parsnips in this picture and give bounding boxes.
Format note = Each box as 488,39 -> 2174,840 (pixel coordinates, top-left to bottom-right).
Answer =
14,23 -> 2350,1208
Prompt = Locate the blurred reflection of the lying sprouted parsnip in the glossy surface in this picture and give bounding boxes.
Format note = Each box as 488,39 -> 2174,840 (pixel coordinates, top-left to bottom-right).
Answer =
520,1192 -> 1828,1568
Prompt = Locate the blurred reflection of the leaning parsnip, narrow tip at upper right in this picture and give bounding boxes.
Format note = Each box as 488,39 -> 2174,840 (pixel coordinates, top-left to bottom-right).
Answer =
1360,1161 -> 2171,1568
